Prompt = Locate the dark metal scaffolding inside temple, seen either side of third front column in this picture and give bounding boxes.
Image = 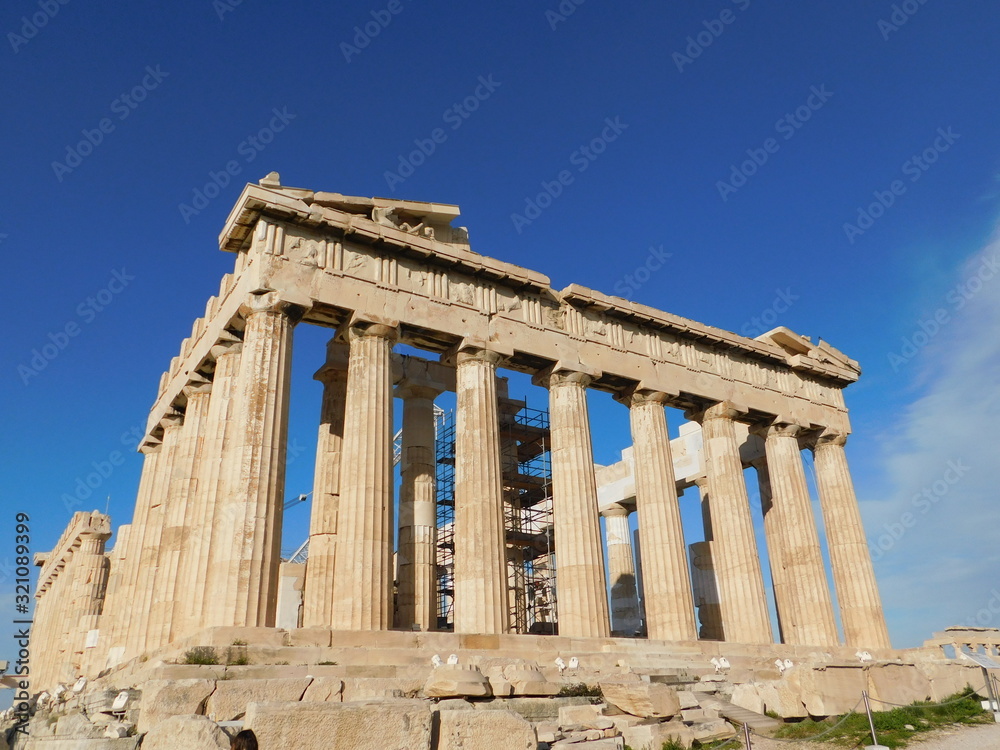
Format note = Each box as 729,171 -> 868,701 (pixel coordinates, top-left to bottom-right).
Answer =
436,378 -> 556,634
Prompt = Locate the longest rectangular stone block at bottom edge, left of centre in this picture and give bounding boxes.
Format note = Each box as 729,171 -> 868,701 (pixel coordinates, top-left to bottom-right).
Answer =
246,700 -> 434,750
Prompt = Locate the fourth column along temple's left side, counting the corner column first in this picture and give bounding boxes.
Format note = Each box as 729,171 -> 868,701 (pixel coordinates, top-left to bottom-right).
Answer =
125,412 -> 184,659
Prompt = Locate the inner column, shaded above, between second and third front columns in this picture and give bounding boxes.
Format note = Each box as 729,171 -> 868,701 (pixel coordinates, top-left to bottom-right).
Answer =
396,380 -> 444,630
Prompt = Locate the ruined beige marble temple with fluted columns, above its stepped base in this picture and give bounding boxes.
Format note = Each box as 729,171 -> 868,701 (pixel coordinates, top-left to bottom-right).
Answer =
36,173 -> 890,688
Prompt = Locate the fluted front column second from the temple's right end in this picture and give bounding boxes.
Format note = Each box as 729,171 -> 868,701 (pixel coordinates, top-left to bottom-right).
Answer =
763,424 -> 838,646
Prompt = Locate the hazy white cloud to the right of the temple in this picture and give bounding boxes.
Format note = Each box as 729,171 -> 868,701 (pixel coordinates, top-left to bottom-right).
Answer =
863,239 -> 1000,647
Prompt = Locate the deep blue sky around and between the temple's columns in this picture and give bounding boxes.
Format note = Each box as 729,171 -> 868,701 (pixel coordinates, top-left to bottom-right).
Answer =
0,0 -> 1000,680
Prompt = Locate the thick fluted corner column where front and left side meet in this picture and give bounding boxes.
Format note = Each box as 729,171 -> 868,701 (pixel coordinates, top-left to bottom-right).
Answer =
220,292 -> 302,627
